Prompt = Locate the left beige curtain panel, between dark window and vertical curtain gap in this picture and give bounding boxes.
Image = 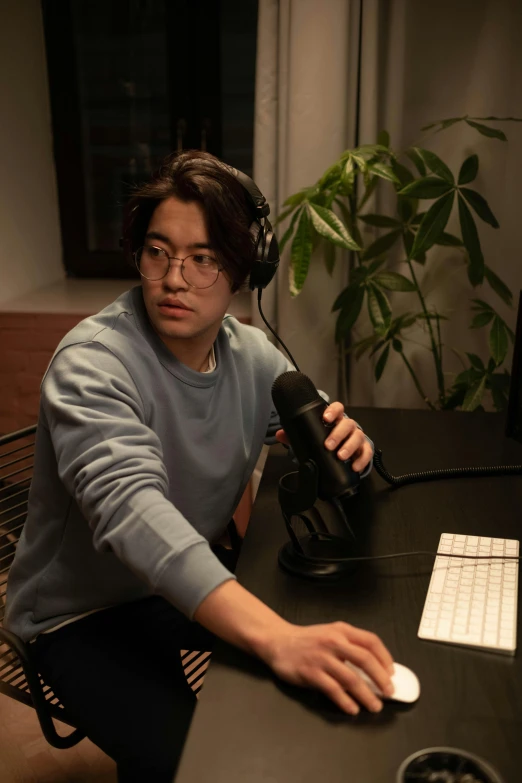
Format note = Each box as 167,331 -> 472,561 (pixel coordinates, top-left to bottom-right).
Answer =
252,0 -> 359,396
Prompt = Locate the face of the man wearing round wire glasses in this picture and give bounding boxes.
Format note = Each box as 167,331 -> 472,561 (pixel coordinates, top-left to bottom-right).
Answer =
141,196 -> 233,354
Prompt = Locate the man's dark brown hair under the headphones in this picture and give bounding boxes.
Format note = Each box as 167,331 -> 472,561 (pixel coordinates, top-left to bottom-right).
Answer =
123,150 -> 255,291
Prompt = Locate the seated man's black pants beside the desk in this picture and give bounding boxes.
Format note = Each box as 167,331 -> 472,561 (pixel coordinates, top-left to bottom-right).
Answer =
31,550 -> 238,783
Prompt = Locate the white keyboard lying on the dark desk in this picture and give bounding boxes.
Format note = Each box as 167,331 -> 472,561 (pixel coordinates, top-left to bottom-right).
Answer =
418,533 -> 519,655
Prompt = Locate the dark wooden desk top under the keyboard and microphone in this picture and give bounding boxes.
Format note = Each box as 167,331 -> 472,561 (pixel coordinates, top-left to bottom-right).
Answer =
176,409 -> 522,783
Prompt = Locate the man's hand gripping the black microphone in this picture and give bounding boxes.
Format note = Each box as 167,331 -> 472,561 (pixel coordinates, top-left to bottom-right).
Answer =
276,402 -> 373,473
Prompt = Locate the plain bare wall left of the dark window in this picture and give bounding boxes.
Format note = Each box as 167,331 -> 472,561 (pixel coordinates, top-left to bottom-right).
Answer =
0,0 -> 64,303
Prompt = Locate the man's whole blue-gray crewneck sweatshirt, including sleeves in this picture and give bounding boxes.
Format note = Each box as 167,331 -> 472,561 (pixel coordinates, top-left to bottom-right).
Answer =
5,286 -> 370,640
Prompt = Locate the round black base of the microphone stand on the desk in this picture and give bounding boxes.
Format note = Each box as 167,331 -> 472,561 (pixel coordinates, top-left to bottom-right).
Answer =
278,533 -> 358,582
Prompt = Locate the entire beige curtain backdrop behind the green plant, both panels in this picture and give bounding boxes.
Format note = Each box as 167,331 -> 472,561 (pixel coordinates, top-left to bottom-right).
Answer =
253,0 -> 522,407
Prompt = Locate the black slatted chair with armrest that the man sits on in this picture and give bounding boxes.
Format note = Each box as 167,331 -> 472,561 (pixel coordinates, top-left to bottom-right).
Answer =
0,426 -> 85,748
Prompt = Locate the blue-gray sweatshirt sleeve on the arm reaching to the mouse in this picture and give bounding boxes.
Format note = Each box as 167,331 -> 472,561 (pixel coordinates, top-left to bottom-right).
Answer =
42,342 -> 235,617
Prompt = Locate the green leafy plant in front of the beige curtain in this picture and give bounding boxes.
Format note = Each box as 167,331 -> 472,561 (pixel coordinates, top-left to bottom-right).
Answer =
277,116 -> 520,411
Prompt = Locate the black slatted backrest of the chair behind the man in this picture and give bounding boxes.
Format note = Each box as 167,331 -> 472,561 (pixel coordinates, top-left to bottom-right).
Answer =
0,425 -> 36,624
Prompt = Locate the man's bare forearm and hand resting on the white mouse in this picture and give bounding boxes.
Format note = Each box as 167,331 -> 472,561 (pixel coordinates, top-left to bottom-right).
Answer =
195,580 -> 393,715
